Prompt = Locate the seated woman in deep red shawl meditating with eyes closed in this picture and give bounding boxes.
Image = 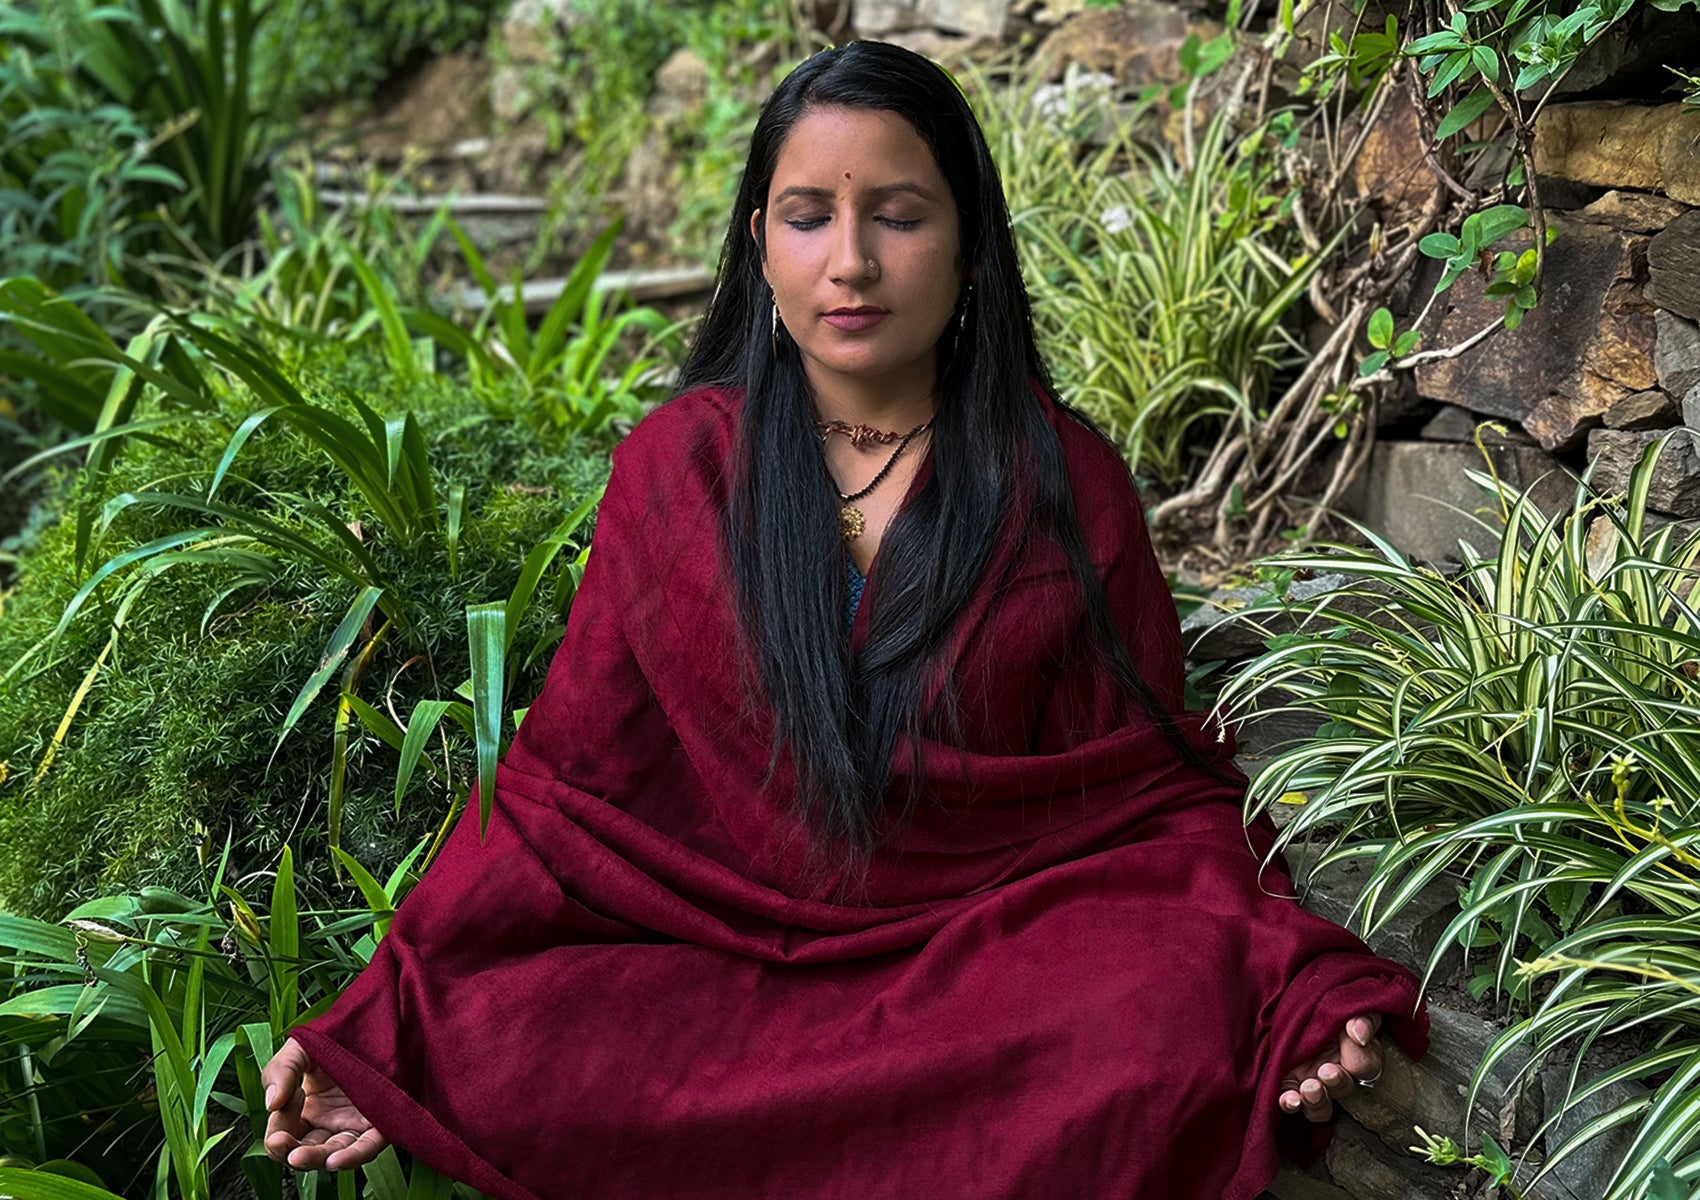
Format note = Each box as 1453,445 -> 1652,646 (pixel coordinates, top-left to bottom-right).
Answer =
265,42 -> 1423,1200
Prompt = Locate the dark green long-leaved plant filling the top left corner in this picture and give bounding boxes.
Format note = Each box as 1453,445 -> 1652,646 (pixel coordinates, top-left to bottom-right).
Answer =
0,0 -> 281,284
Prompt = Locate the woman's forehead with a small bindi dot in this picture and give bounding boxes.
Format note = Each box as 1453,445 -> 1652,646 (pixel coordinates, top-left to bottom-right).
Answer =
772,107 -> 945,192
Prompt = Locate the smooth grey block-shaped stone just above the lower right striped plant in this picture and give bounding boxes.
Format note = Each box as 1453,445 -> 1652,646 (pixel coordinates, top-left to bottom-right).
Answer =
1341,442 -> 1576,563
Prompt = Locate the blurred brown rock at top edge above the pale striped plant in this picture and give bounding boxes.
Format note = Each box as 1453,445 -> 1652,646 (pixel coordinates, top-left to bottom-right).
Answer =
1029,0 -> 1222,88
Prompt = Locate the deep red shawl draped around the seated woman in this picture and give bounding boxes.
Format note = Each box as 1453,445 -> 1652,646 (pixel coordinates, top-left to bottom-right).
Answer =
296,391 -> 1426,1200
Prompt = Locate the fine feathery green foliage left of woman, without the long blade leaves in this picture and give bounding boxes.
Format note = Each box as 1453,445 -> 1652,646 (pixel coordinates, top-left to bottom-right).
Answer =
0,350 -> 607,918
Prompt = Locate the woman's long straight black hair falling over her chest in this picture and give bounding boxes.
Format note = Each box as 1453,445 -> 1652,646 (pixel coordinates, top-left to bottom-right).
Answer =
677,41 -> 1199,867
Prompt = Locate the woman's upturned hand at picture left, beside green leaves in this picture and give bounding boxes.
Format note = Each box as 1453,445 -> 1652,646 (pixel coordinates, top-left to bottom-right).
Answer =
260,1037 -> 389,1171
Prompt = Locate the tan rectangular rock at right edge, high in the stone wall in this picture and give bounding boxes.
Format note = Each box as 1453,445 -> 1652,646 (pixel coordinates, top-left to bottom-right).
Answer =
1535,100 -> 1700,204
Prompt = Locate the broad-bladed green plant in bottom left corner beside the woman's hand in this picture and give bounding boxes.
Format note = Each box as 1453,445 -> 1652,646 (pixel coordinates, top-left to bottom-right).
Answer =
0,841 -> 476,1200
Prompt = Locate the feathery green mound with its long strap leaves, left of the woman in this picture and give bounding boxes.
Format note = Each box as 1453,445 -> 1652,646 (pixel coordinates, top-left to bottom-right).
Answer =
0,329 -> 607,914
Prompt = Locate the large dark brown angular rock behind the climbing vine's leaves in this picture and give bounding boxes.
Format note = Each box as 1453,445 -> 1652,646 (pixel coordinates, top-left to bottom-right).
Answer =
1416,214 -> 1656,450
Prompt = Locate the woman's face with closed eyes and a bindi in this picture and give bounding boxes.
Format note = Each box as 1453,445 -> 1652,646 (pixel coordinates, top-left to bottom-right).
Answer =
750,109 -> 962,398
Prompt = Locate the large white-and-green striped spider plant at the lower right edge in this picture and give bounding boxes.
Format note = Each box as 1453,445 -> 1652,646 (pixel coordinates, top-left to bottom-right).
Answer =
1222,444 -> 1700,1200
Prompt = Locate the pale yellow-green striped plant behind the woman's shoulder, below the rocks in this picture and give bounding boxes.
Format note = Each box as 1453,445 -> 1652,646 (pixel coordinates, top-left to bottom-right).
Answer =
964,65 -> 1316,488
